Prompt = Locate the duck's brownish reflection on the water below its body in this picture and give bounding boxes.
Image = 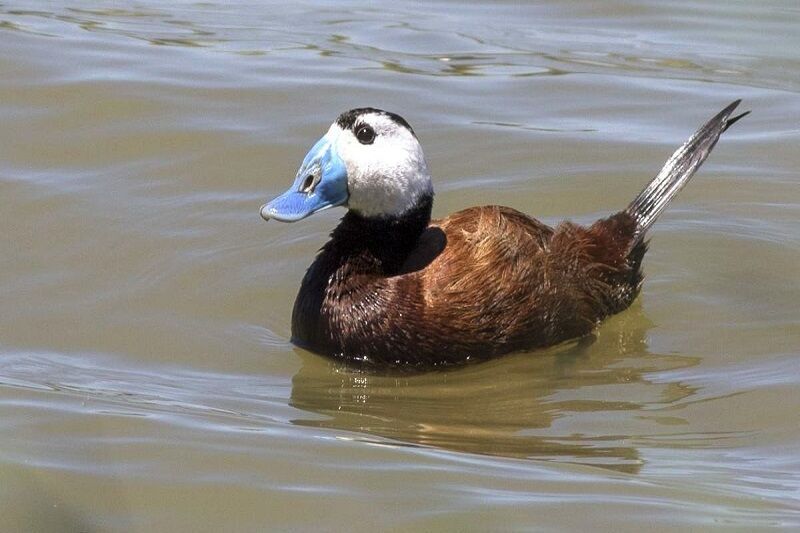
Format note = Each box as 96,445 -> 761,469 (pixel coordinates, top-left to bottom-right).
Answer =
291,304 -> 697,473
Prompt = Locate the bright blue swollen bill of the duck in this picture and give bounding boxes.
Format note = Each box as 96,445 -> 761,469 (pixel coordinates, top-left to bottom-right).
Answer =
261,132 -> 348,222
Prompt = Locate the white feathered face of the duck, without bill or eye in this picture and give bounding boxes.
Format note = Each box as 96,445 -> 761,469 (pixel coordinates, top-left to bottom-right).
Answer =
328,112 -> 433,217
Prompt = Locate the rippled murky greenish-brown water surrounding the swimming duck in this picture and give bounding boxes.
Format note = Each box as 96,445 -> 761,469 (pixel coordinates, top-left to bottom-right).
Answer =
0,0 -> 800,531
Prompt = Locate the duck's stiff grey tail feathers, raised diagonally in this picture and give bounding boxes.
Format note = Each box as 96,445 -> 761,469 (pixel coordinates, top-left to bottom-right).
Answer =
625,100 -> 750,245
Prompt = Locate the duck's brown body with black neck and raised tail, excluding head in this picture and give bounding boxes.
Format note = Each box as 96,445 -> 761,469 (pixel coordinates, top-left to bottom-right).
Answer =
268,102 -> 743,370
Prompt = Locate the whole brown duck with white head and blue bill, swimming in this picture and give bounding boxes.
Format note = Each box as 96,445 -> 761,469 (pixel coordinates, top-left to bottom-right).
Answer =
260,100 -> 749,372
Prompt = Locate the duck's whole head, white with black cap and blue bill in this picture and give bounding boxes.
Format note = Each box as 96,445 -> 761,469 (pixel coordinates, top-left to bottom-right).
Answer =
261,108 -> 433,222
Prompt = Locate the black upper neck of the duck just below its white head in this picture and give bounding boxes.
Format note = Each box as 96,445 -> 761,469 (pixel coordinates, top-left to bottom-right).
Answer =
324,196 -> 433,275
